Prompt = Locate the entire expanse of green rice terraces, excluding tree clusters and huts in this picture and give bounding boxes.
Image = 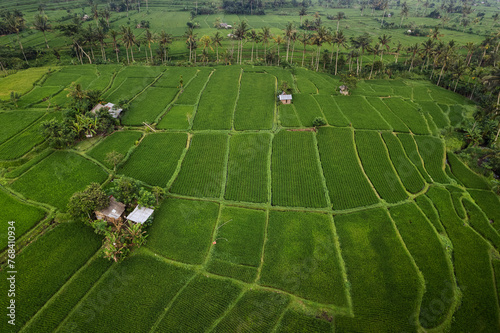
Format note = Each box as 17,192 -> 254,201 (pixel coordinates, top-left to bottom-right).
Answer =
0,65 -> 500,332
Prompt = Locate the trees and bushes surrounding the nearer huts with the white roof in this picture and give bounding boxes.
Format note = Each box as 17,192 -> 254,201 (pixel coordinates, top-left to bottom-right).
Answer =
68,177 -> 165,262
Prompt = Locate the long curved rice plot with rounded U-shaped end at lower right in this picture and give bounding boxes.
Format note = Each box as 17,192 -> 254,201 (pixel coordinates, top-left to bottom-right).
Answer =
389,203 -> 457,328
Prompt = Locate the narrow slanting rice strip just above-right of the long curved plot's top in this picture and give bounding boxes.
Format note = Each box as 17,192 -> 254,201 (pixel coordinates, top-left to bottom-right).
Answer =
382,132 -> 425,193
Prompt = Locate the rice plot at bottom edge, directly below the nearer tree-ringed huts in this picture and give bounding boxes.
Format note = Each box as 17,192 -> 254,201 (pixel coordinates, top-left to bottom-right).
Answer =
58,254 -> 192,332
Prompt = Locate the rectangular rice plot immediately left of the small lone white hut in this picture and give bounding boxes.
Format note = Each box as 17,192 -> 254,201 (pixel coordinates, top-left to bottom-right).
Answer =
234,73 -> 276,131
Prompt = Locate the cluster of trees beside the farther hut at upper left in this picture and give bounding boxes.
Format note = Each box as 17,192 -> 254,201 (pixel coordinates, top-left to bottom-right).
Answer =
40,83 -> 117,149
